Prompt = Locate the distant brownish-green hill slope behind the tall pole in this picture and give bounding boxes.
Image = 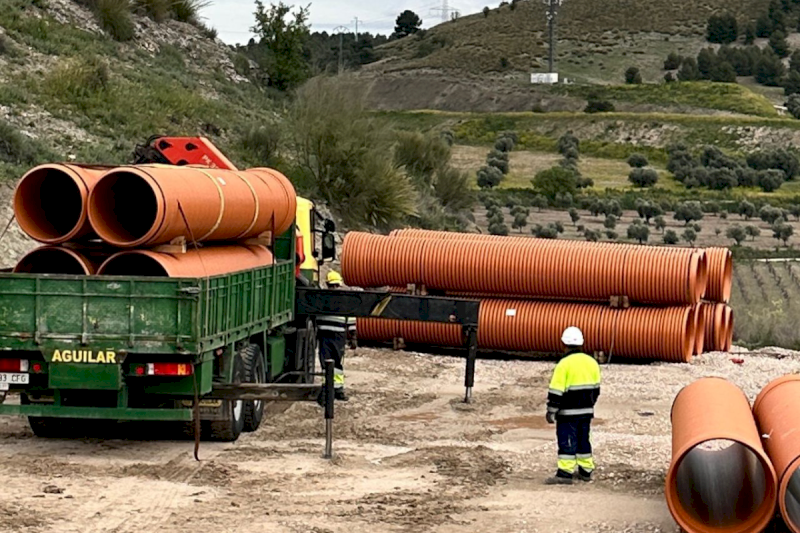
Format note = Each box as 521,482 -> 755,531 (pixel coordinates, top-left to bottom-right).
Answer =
362,0 -> 768,112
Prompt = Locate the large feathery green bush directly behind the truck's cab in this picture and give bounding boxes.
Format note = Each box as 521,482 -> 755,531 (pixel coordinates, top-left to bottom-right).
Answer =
287,76 -> 416,229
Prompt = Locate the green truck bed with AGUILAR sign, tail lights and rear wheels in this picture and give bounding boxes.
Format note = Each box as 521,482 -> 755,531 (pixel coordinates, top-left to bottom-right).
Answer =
0,229 -> 314,440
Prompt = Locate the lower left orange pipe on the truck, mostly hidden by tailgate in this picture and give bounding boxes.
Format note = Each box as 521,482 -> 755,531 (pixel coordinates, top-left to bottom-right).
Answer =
14,245 -> 111,276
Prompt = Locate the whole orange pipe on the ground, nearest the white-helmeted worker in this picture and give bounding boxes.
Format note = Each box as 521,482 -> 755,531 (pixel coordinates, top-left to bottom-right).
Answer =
664,378 -> 777,533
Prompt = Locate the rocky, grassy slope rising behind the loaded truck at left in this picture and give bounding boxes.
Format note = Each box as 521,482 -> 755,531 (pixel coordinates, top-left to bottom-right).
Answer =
0,0 -> 275,266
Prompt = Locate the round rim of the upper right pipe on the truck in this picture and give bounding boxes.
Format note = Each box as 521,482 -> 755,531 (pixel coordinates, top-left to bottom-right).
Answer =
87,166 -> 166,247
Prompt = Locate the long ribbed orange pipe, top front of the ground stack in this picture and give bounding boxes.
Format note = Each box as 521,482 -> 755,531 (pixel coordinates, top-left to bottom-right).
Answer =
342,232 -> 706,304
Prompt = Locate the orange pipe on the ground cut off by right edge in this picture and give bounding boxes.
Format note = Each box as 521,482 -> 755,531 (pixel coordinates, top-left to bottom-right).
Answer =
753,374 -> 800,533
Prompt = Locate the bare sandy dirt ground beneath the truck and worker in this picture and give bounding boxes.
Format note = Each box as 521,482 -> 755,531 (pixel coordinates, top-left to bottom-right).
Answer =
0,348 -> 800,533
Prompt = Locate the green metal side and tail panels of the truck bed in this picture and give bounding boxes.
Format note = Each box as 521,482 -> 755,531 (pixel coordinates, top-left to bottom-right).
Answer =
0,261 -> 295,361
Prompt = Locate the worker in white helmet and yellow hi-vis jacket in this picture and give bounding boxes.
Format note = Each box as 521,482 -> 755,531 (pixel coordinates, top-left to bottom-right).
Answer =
545,327 -> 600,485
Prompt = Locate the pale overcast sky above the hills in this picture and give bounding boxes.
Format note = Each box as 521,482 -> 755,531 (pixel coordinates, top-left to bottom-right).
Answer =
203,0 -> 488,44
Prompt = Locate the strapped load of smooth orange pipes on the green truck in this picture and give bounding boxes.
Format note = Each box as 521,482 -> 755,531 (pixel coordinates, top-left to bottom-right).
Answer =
14,164 -> 297,277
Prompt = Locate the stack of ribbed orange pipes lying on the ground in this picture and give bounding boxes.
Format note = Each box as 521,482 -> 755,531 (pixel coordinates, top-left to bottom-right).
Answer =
342,230 -> 733,362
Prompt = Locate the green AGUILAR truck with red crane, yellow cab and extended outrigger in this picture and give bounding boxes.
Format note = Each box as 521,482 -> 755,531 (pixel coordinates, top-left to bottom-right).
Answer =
0,137 -> 479,448
